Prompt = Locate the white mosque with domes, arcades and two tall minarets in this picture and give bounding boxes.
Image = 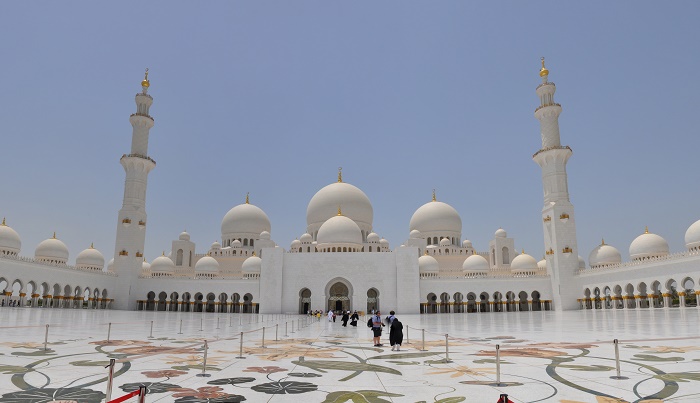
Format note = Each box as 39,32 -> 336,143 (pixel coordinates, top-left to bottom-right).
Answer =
0,63 -> 700,314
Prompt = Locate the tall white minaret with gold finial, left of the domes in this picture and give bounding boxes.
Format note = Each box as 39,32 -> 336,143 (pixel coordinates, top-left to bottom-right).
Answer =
112,69 -> 156,310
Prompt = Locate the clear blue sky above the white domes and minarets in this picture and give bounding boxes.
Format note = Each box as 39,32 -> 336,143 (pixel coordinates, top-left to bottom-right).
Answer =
0,1 -> 700,263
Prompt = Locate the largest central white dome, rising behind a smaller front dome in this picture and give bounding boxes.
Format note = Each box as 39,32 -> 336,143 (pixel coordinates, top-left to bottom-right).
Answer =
306,182 -> 374,232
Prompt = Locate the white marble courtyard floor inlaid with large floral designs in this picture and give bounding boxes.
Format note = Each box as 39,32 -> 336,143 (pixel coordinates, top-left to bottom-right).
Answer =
0,308 -> 700,403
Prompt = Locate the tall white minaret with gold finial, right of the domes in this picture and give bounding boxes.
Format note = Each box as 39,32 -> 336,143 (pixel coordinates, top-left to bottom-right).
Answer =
532,57 -> 580,311
